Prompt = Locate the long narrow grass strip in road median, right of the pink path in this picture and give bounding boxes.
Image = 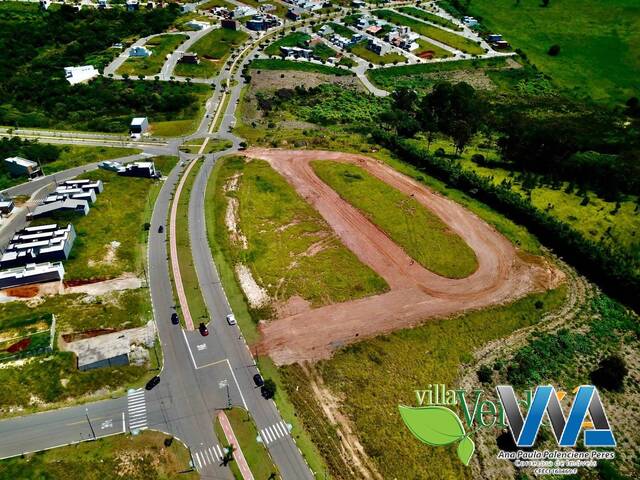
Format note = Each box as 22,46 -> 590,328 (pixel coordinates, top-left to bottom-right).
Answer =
173,162 -> 209,326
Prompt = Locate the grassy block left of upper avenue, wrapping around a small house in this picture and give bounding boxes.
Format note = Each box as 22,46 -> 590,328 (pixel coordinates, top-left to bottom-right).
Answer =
173,28 -> 249,78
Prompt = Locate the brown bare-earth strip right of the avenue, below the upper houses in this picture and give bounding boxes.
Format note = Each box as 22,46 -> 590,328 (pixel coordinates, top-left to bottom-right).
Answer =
251,70 -> 365,91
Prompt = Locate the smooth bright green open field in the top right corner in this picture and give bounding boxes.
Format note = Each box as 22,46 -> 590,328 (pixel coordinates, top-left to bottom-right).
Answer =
469,0 -> 640,103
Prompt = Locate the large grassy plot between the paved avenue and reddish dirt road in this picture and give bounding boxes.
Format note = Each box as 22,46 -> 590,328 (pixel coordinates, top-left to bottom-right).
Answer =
215,157 -> 387,314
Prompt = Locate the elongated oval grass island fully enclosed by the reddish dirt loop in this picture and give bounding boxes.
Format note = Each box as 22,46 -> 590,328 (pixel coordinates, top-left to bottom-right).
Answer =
312,161 -> 478,278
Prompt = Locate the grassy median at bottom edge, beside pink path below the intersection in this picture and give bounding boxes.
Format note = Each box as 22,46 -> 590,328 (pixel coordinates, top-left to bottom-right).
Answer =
218,407 -> 280,480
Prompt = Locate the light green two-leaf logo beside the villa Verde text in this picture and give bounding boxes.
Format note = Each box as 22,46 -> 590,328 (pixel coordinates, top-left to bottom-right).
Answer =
398,405 -> 476,465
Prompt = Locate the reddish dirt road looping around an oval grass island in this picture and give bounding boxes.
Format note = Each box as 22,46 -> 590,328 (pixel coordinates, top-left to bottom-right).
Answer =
244,148 -> 564,365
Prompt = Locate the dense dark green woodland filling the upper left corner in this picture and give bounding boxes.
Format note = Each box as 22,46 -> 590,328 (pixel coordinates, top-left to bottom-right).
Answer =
0,4 -> 202,131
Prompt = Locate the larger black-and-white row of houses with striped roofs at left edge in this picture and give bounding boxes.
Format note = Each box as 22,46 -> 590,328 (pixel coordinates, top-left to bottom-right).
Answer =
0,224 -> 77,268
